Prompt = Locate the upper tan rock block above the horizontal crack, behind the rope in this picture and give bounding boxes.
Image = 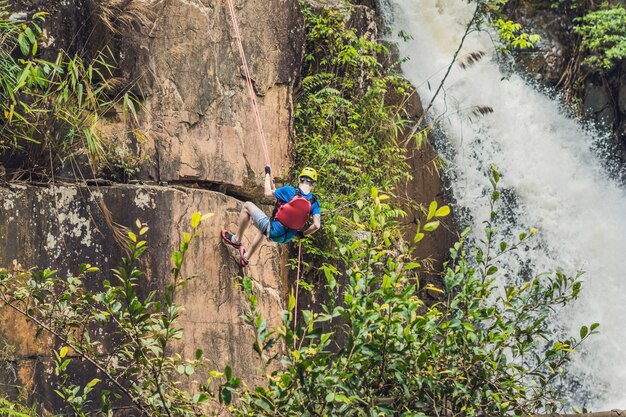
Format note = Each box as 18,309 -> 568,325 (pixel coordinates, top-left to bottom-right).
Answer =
129,0 -> 304,190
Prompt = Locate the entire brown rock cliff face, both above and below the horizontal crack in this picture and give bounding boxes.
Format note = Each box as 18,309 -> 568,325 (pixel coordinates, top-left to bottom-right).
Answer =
0,0 -> 304,411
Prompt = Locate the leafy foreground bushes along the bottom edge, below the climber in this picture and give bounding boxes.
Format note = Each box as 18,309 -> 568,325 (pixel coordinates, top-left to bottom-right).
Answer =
0,168 -> 598,417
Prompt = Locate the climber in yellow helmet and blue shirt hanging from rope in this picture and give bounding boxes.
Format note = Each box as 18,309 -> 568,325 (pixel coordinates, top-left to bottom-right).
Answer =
222,166 -> 321,267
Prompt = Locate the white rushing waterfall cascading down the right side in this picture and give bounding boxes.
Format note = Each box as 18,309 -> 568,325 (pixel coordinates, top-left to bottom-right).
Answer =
386,0 -> 626,411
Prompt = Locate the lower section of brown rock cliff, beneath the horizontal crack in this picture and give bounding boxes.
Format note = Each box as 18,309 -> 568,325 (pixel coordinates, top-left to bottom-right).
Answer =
0,184 -> 286,410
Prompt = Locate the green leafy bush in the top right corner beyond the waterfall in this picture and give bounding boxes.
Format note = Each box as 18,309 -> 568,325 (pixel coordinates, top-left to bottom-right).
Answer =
574,5 -> 626,73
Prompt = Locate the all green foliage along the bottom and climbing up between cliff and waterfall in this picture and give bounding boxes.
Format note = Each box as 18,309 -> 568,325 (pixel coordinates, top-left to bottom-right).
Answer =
0,2 -> 598,417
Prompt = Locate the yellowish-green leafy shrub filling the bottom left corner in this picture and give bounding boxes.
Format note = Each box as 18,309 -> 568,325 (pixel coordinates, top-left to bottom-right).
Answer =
0,213 -> 217,416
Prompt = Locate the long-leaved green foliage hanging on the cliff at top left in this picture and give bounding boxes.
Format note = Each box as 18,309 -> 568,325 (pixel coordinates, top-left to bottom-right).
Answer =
0,0 -> 141,173
